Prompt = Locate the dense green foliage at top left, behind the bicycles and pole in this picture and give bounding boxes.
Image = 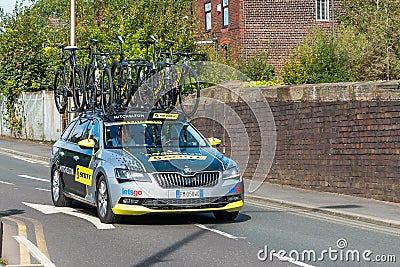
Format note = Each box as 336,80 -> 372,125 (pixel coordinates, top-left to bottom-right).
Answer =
0,0 -> 199,133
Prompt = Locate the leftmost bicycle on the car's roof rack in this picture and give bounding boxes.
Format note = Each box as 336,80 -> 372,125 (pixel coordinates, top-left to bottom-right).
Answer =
53,44 -> 85,114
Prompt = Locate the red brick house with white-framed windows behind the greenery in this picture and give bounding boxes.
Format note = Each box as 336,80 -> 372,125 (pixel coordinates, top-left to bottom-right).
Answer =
194,0 -> 340,70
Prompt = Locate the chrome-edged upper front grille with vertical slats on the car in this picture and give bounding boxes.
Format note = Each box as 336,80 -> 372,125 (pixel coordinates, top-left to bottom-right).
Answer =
153,172 -> 219,188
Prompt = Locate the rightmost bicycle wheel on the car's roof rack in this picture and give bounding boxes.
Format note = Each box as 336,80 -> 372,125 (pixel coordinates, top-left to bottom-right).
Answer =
178,67 -> 200,116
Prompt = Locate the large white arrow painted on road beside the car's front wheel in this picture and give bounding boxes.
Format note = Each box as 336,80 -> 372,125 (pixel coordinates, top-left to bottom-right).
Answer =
22,202 -> 115,230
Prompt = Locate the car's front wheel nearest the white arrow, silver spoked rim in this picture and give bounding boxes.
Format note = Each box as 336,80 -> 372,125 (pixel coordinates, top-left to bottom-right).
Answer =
96,175 -> 118,223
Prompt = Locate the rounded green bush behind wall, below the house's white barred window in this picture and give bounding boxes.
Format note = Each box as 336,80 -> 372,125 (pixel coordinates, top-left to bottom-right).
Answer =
282,29 -> 353,84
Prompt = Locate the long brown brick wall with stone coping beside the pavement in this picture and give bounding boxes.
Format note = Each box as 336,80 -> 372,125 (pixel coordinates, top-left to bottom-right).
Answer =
193,82 -> 400,202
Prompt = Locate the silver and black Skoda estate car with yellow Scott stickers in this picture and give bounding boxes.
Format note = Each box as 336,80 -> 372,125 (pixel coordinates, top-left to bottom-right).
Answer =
50,112 -> 244,223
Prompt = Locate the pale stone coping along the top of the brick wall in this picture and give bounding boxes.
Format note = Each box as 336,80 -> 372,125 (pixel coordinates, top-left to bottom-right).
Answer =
201,80 -> 400,102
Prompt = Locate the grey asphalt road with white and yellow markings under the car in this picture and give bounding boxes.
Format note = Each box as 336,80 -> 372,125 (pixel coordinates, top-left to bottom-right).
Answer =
0,151 -> 400,266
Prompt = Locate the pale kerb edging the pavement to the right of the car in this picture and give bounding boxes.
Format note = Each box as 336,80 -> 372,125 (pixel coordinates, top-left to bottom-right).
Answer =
245,195 -> 400,229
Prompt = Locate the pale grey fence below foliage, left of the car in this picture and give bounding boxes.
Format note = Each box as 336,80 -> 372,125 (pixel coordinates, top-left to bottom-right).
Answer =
0,91 -> 62,141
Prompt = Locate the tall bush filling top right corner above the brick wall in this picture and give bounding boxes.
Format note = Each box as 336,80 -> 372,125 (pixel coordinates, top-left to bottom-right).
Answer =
340,0 -> 400,80
